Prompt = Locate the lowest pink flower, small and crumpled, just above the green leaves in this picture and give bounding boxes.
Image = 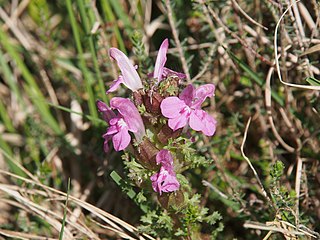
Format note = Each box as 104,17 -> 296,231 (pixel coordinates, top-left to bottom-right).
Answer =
150,150 -> 180,195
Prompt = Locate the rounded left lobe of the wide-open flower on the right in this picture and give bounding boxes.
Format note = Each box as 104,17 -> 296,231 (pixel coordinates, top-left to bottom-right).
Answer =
160,97 -> 186,118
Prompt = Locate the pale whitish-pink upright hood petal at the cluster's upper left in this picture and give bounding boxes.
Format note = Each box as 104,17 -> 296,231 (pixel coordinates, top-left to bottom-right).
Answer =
109,48 -> 143,91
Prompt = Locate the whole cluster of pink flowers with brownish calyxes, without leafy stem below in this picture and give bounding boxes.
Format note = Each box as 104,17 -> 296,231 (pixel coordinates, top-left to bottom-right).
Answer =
97,39 -> 216,195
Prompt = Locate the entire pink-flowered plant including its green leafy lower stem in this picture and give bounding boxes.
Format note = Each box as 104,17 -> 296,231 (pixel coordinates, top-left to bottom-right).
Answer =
97,39 -> 222,239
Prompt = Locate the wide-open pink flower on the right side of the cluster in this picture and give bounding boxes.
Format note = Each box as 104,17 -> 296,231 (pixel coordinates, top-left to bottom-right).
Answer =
160,84 -> 217,136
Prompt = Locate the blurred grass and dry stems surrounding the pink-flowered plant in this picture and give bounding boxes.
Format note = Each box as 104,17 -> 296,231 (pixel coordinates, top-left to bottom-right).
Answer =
0,0 -> 320,239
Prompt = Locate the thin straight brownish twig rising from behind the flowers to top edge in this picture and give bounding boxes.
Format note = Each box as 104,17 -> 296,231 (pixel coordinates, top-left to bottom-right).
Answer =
165,0 -> 191,83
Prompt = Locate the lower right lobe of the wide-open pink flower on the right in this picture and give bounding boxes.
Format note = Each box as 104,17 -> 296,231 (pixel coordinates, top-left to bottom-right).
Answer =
189,110 -> 217,136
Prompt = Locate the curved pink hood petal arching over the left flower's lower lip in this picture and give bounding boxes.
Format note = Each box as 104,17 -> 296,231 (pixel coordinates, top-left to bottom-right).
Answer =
110,97 -> 145,141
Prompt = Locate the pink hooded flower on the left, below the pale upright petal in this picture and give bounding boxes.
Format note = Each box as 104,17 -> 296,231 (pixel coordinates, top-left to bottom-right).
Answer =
97,97 -> 145,152
